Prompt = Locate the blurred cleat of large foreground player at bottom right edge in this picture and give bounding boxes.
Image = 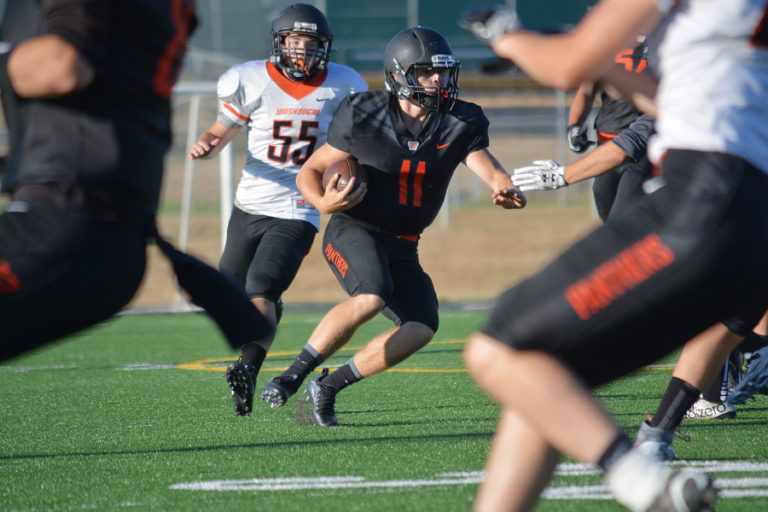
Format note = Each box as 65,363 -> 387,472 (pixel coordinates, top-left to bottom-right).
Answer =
647,468 -> 717,512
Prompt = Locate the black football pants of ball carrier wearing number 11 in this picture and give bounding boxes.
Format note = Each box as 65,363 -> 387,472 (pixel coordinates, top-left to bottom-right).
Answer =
322,215 -> 439,332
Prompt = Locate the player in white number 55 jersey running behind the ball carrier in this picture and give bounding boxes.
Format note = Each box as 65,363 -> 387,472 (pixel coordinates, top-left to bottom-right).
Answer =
188,4 -> 368,416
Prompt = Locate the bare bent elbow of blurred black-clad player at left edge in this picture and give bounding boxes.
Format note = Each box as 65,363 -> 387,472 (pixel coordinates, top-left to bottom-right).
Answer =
2,34 -> 95,98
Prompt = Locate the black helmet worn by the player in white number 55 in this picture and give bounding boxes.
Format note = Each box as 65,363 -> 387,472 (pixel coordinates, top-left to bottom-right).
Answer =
269,4 -> 333,81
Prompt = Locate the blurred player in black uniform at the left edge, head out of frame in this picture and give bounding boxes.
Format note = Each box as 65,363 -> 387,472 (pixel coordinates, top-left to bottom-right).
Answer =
0,0 -> 272,359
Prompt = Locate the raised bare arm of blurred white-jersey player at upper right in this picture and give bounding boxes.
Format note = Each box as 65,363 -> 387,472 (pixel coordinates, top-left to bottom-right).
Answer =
464,0 -> 662,90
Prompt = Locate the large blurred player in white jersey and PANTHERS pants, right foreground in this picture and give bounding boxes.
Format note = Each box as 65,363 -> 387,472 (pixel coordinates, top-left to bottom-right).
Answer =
464,0 -> 768,511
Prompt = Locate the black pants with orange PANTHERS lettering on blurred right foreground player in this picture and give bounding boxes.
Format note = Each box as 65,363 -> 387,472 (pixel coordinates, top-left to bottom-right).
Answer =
483,150 -> 768,386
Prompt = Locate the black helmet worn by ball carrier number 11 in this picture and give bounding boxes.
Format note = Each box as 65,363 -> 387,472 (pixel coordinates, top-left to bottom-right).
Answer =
384,27 -> 461,112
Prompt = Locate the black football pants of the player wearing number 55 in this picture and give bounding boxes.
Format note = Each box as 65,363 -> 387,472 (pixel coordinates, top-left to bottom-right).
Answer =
219,206 -> 317,302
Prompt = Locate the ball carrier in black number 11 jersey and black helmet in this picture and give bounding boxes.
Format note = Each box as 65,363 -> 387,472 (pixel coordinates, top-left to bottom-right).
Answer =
262,27 -> 525,426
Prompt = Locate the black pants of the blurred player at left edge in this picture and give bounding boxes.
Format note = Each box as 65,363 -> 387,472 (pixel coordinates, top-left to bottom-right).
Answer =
0,196 -> 148,359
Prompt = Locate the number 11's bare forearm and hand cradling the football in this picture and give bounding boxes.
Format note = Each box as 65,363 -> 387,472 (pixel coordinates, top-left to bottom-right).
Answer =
296,143 -> 367,213
